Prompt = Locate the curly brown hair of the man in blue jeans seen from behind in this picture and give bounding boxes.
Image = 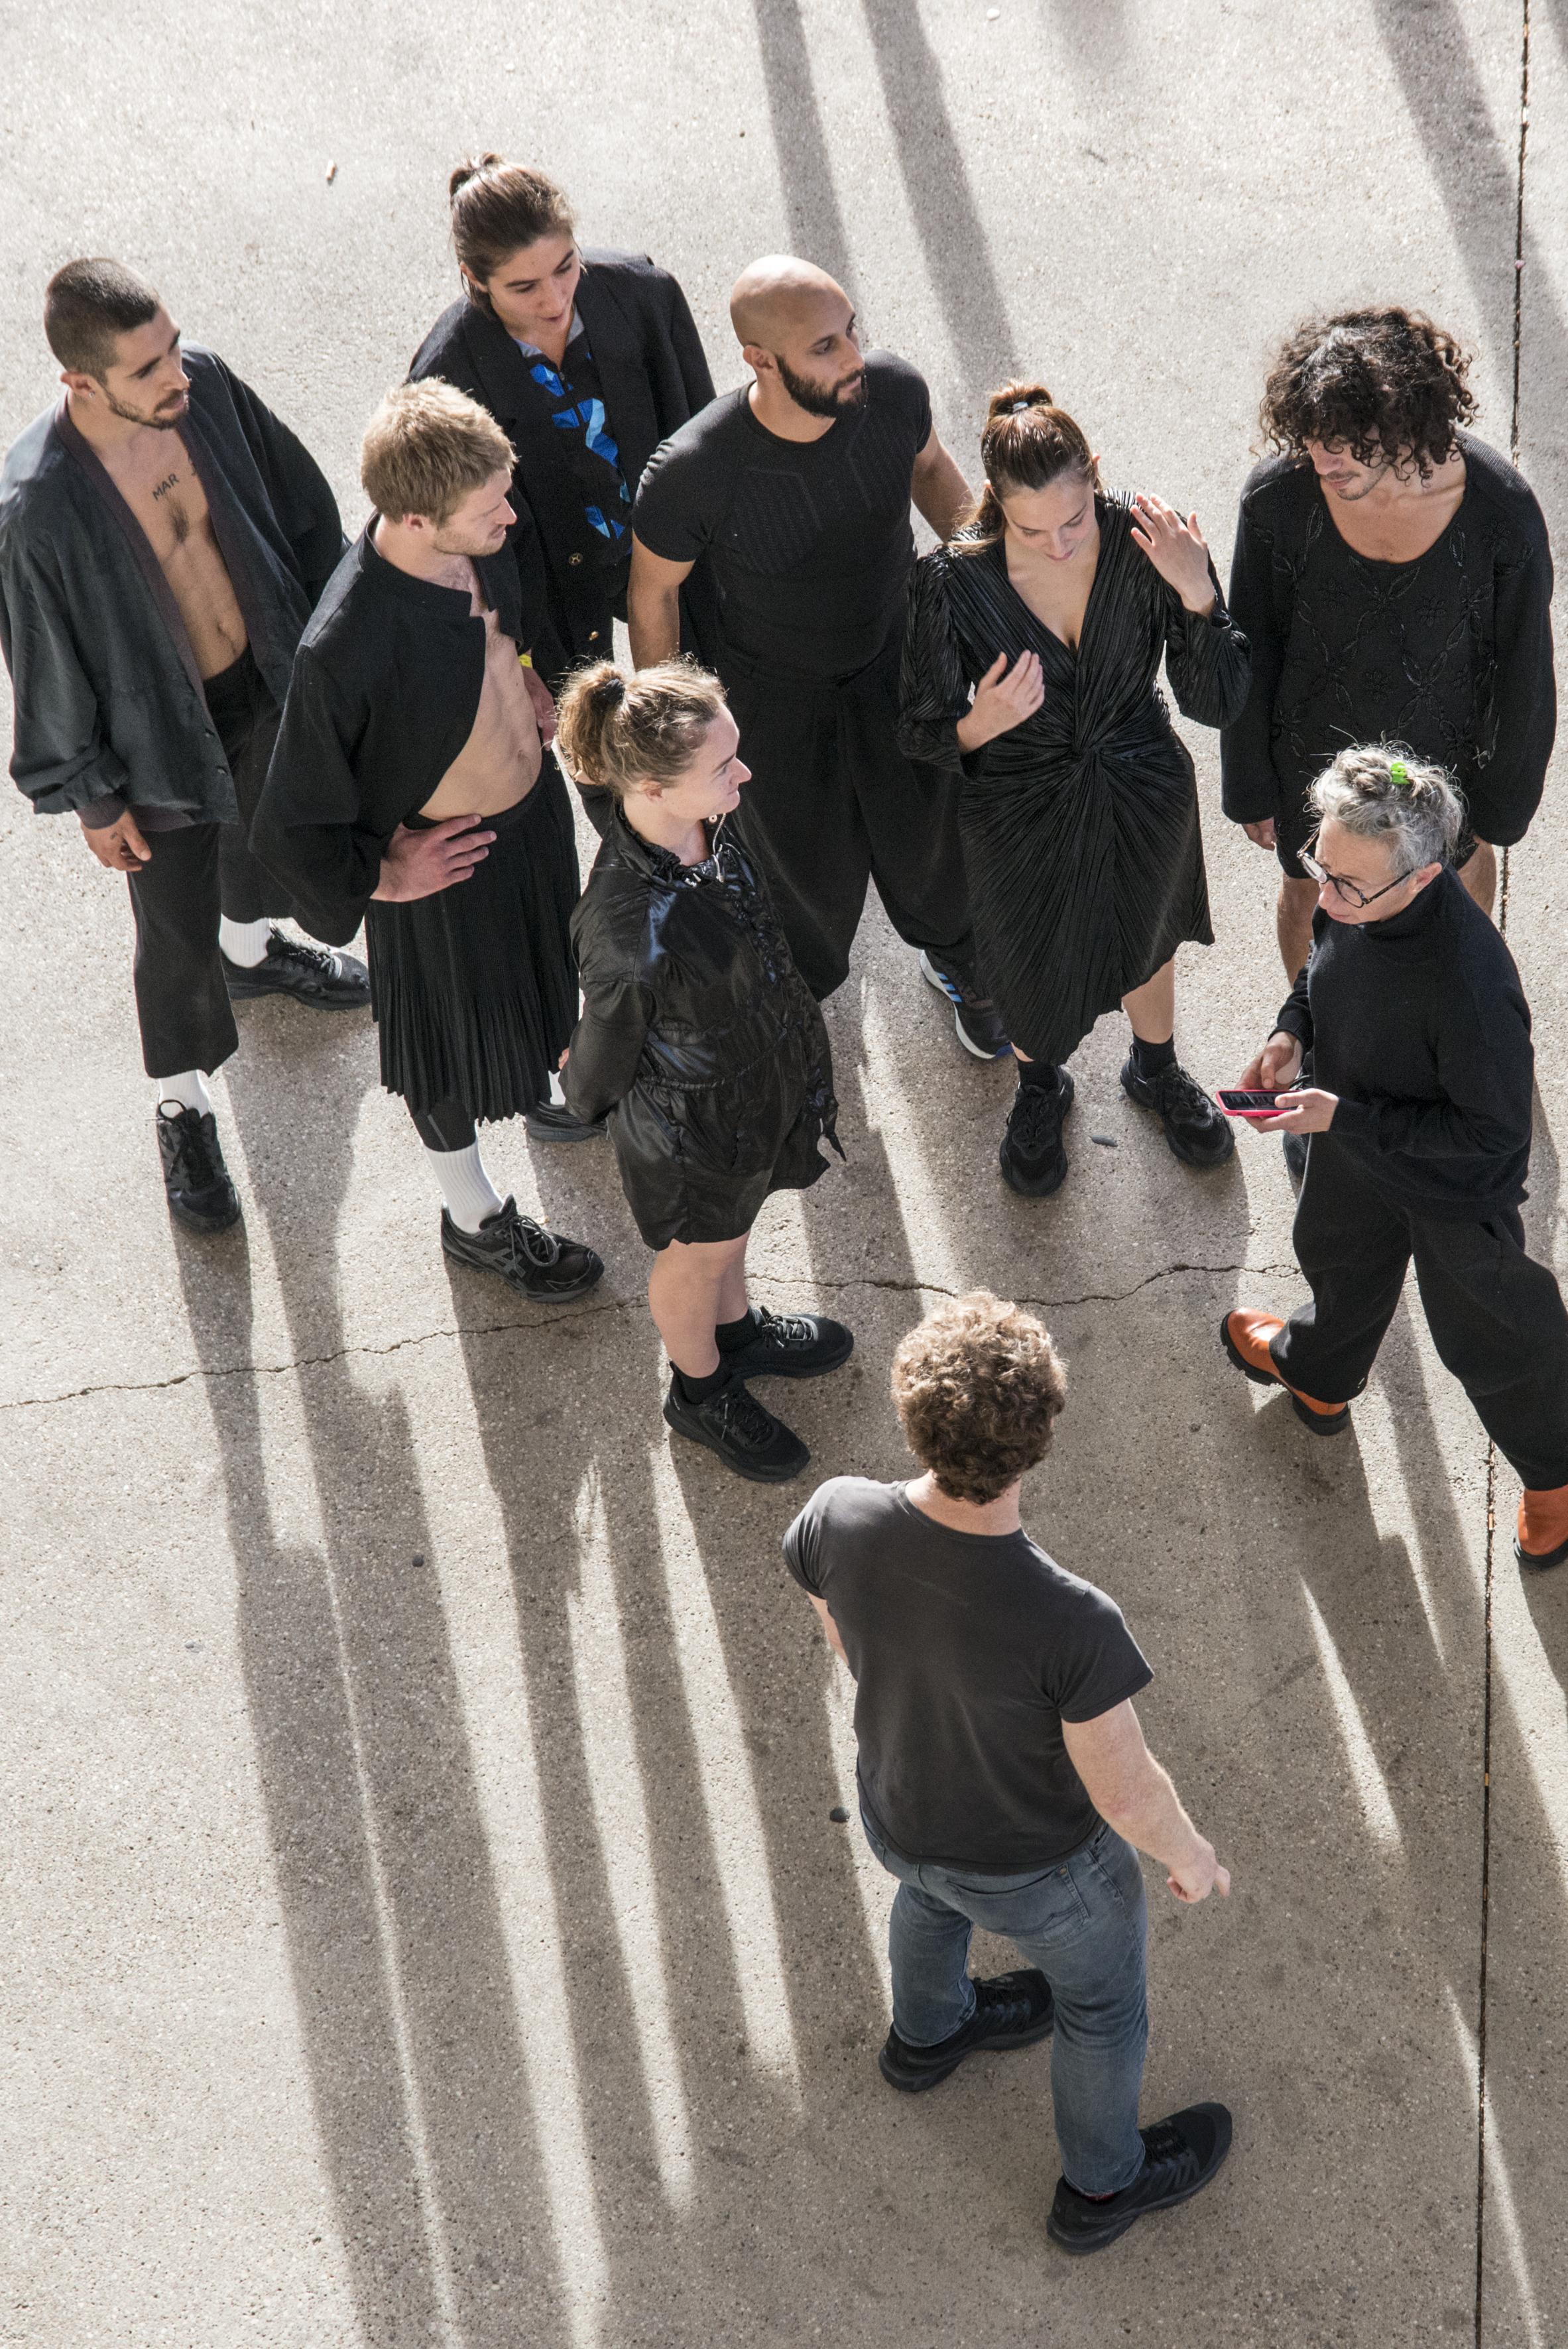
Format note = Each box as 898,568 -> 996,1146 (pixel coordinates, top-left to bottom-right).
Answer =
892,1290 -> 1068,1501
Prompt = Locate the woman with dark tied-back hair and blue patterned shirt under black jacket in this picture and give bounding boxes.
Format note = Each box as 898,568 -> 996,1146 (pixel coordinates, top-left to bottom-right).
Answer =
408,155 -> 713,691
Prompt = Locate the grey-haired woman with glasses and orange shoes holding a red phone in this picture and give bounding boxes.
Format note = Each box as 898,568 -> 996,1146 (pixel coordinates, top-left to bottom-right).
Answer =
1221,743 -> 1568,1567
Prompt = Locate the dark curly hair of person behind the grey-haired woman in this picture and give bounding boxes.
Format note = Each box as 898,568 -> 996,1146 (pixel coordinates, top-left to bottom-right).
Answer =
1258,310 -> 1477,479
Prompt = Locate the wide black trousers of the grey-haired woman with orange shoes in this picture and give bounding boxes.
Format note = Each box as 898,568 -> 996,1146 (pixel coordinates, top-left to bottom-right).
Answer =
1272,1134 -> 1568,1492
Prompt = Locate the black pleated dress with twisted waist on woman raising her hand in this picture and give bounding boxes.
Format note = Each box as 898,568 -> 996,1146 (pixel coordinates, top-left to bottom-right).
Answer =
899,496 -> 1249,1061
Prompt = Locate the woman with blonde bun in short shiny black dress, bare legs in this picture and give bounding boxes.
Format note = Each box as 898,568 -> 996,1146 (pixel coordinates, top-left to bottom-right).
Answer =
559,662 -> 855,1484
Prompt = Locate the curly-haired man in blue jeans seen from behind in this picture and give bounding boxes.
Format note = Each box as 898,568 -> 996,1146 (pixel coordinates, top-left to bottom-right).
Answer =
784,1290 -> 1230,2253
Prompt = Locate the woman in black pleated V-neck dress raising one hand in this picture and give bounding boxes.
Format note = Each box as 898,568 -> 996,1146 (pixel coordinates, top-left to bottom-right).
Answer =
899,385 -> 1251,1198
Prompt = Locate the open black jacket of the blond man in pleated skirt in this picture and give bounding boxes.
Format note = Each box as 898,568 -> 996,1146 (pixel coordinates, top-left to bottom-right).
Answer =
251,516 -> 521,947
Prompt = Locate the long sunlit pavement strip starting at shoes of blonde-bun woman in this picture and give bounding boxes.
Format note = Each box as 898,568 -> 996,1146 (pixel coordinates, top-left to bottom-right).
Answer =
648,1445 -> 800,2105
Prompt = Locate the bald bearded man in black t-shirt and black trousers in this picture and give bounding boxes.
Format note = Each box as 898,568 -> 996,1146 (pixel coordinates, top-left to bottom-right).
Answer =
629,254 -> 1009,1059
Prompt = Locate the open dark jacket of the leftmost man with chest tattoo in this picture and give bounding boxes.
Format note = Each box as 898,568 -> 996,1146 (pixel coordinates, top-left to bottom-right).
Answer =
0,343 -> 343,825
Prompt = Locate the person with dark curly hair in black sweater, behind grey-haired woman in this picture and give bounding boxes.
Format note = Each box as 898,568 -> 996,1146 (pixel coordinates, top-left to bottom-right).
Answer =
1221,308 -> 1556,977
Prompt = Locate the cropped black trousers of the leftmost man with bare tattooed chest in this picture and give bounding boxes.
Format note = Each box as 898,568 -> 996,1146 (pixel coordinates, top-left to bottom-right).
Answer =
127,650 -> 296,1076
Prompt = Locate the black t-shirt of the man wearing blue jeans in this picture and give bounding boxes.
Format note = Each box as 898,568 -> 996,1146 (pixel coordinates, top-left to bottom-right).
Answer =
784,1475 -> 1152,1874
